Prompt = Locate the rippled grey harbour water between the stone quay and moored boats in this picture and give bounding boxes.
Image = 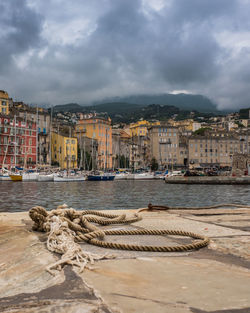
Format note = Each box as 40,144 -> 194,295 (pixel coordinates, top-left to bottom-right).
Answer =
0,180 -> 250,212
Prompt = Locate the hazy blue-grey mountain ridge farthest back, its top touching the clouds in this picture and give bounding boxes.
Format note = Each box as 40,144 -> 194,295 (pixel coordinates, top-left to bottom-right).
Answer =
95,93 -> 217,112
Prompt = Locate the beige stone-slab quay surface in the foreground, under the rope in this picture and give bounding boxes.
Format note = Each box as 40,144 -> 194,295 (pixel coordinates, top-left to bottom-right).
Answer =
0,208 -> 250,313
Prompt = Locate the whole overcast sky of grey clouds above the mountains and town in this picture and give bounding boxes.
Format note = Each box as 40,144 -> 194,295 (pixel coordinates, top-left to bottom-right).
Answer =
0,0 -> 250,109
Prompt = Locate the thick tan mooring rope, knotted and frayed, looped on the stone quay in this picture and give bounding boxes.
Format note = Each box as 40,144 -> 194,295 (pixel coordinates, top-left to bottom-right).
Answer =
29,205 -> 209,275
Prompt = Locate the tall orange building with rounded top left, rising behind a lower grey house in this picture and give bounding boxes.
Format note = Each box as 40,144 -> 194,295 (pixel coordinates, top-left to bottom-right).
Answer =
76,115 -> 112,169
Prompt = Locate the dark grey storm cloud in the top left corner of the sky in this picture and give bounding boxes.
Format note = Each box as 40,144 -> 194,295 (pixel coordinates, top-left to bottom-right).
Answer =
0,0 -> 41,72
